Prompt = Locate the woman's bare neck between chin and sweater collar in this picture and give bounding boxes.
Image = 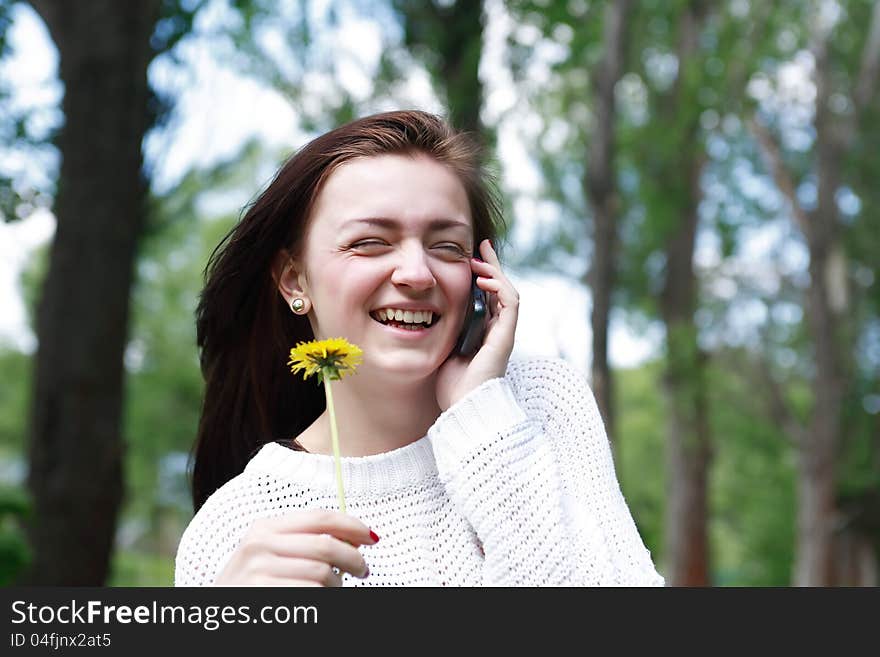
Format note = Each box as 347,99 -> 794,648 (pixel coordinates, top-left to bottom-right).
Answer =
298,372 -> 440,456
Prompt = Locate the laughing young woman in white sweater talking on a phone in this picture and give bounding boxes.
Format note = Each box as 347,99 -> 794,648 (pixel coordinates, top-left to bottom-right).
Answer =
175,111 -> 663,586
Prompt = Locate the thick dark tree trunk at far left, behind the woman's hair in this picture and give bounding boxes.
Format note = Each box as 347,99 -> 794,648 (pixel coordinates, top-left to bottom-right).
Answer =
22,0 -> 159,586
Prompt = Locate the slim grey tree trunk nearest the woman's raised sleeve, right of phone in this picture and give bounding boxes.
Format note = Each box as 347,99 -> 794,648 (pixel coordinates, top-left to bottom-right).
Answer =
584,0 -> 630,456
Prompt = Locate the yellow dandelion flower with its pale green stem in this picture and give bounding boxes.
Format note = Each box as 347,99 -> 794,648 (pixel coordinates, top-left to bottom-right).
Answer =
287,338 -> 363,513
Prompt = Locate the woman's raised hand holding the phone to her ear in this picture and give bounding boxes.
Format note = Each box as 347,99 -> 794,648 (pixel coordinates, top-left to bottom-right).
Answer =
436,240 -> 519,411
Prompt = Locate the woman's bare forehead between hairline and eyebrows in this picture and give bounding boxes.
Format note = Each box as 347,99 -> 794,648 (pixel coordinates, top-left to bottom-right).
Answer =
310,154 -> 472,232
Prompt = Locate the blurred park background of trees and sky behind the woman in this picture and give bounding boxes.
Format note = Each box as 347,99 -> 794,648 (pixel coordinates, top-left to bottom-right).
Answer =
0,0 -> 880,586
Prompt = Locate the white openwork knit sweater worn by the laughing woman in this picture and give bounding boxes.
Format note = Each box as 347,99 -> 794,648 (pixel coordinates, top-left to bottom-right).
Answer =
174,359 -> 664,586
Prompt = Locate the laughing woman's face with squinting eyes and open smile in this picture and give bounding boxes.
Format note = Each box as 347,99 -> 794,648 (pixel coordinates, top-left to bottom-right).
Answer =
288,155 -> 474,380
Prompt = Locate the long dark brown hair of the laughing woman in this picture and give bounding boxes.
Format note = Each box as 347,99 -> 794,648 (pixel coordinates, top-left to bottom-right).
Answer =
192,111 -> 503,511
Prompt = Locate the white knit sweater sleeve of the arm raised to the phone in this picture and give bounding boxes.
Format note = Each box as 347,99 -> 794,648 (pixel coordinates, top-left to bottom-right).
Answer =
429,360 -> 664,586
